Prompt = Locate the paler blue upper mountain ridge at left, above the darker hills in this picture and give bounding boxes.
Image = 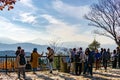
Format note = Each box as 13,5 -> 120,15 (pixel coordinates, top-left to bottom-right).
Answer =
0,43 -> 48,53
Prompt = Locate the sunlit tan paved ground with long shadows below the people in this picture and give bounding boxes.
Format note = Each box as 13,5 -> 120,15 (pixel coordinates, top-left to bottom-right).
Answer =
0,68 -> 120,80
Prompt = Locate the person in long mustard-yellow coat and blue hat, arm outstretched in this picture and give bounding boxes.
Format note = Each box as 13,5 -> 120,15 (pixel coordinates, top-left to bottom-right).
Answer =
30,48 -> 43,74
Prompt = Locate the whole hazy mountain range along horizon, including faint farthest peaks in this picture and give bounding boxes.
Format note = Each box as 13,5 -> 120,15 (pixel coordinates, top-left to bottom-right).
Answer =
0,37 -> 116,53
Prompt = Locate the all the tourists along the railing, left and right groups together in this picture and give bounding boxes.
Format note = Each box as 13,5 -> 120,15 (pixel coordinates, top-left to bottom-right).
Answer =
15,46 -> 120,79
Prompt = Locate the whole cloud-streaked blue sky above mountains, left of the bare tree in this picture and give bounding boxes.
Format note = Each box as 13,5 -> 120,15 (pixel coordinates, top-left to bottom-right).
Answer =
0,0 -> 114,44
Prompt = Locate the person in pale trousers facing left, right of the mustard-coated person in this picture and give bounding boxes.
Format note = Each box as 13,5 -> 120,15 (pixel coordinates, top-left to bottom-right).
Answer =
47,47 -> 54,73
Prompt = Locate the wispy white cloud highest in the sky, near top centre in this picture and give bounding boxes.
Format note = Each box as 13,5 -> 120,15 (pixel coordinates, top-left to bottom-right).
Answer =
53,0 -> 90,19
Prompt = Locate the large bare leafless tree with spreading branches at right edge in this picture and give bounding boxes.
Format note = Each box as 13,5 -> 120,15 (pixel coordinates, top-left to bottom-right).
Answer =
85,0 -> 120,46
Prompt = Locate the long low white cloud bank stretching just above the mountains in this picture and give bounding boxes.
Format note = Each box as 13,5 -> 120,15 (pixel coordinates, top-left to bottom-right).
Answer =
0,14 -> 115,44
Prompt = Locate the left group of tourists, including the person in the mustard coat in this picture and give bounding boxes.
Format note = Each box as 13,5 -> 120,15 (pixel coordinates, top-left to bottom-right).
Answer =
15,46 -> 54,80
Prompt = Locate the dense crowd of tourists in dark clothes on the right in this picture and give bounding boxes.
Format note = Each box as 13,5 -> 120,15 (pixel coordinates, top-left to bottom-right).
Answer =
69,47 -> 120,76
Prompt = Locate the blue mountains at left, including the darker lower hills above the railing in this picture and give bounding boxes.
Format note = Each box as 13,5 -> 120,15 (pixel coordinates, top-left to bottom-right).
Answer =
0,43 -> 48,56
